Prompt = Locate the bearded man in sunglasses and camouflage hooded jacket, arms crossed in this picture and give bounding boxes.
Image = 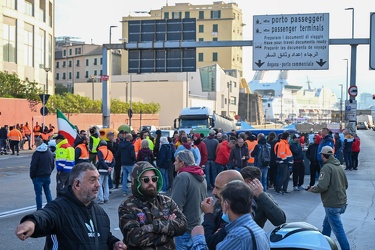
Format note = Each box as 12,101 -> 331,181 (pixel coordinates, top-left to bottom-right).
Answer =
118,161 -> 187,249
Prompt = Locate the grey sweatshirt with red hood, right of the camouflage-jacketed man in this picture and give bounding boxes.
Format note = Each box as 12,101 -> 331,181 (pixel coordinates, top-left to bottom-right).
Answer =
171,166 -> 207,233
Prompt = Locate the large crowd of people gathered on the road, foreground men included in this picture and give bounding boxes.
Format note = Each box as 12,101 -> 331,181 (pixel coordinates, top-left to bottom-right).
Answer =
16,127 -> 360,249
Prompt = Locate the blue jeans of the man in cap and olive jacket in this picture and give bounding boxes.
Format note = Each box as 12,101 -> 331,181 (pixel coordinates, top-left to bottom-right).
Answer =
322,205 -> 350,250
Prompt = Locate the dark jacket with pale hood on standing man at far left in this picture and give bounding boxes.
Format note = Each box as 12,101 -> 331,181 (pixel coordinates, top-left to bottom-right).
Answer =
30,143 -> 55,179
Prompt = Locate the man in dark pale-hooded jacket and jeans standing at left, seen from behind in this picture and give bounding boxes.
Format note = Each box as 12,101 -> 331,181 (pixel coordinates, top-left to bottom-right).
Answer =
30,138 -> 55,210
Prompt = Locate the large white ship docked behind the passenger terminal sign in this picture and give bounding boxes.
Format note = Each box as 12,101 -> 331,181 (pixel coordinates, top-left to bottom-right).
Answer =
248,71 -> 340,123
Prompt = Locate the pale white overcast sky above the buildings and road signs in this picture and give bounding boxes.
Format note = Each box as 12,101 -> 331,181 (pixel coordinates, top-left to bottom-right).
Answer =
55,0 -> 375,98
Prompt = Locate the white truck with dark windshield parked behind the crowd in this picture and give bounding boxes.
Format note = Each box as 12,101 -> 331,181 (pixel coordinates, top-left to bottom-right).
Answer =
174,107 -> 236,136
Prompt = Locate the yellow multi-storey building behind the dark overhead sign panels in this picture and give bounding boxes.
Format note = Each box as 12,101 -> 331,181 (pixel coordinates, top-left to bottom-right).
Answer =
121,1 -> 244,77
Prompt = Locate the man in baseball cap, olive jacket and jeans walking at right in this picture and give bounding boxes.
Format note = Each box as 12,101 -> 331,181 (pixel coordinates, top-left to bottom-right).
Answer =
309,146 -> 350,250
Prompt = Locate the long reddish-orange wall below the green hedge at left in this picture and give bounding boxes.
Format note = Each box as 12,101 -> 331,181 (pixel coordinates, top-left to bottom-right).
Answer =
0,98 -> 159,131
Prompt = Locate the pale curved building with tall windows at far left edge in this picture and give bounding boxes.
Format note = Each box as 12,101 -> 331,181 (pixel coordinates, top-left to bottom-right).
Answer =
0,0 -> 55,93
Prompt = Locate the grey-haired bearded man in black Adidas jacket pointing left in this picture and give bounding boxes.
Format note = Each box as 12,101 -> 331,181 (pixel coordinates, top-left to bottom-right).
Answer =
16,162 -> 127,250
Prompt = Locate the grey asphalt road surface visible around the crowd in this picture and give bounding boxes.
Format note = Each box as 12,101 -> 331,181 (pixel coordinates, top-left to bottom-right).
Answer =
0,130 -> 375,250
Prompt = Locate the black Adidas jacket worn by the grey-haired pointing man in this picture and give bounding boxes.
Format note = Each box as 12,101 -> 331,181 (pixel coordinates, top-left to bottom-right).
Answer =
21,186 -> 119,250
